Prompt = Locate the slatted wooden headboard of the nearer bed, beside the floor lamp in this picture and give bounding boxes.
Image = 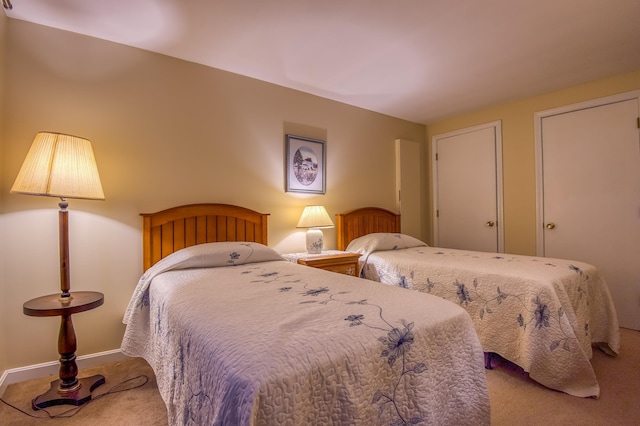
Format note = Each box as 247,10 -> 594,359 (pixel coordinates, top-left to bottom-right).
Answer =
140,204 -> 269,271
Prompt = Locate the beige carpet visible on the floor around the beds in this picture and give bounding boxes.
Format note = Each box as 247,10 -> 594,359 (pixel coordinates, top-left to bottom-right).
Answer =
0,329 -> 640,426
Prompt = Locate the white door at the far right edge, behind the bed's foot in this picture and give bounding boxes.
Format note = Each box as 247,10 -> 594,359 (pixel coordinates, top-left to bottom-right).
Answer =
537,93 -> 640,330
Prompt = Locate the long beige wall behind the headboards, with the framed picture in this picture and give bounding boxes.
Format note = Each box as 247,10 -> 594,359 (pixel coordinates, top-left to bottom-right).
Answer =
0,20 -> 425,371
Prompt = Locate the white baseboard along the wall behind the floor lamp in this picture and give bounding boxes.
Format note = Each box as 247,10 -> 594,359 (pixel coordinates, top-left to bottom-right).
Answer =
0,349 -> 129,397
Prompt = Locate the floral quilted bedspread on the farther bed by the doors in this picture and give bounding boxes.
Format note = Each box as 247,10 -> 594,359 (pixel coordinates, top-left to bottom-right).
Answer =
347,234 -> 620,397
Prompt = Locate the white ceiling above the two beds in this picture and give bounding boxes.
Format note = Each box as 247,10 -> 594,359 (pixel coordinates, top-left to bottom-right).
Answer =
6,0 -> 640,124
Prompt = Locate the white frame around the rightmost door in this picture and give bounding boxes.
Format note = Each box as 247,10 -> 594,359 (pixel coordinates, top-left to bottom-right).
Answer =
534,90 -> 640,257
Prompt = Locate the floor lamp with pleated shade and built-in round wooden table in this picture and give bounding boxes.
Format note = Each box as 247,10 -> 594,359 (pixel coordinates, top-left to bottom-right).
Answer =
11,132 -> 105,409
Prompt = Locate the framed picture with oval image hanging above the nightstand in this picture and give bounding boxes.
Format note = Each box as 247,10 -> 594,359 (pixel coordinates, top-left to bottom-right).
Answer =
285,135 -> 326,194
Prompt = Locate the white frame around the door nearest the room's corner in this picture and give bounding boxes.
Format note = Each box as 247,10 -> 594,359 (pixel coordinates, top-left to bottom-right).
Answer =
431,120 -> 504,253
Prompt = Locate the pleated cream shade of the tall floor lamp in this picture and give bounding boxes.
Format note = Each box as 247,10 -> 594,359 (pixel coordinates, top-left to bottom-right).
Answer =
11,132 -> 104,200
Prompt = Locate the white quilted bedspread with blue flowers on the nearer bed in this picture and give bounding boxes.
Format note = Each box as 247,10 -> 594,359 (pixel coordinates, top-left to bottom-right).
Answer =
122,243 -> 490,425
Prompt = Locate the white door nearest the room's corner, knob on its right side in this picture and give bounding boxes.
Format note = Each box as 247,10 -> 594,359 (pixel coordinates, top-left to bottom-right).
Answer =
432,121 -> 504,252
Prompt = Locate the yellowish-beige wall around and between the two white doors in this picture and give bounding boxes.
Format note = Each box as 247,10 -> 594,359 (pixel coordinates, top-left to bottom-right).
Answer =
422,70 -> 640,255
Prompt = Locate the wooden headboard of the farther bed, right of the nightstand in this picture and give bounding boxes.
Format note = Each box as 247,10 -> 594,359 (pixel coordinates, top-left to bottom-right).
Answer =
336,207 -> 400,250
